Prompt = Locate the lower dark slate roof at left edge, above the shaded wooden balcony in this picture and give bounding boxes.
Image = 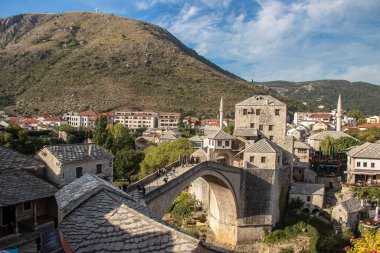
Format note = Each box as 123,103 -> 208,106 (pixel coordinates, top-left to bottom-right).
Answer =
0,169 -> 58,207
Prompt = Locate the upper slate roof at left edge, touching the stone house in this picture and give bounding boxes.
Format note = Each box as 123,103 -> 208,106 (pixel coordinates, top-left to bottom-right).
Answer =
0,146 -> 45,170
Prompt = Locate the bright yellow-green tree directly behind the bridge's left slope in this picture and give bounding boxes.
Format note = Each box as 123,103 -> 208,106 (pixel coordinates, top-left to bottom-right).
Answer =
140,138 -> 194,177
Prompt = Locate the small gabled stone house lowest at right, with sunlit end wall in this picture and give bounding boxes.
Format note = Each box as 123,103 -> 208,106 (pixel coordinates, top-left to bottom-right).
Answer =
331,197 -> 364,228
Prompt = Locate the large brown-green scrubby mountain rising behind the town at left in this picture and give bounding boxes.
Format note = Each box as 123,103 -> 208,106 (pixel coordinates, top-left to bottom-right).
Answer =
0,12 -> 274,115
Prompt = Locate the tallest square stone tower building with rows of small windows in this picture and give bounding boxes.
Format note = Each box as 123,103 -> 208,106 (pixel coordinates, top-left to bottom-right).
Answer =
235,95 -> 287,143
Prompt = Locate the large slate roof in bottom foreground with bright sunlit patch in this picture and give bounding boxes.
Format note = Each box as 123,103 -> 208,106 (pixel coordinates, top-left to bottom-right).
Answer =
56,175 -> 221,253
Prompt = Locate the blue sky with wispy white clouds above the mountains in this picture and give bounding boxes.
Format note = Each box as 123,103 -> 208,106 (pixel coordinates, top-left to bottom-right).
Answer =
0,0 -> 380,84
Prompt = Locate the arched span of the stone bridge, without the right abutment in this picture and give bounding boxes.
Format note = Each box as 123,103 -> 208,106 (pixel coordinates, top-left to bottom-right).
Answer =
144,162 -> 240,245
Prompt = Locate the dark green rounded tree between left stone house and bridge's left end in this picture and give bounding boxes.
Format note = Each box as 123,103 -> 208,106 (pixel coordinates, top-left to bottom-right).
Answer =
115,149 -> 144,183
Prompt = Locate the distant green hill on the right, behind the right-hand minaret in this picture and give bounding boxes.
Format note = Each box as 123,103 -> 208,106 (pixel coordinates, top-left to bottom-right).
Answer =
256,80 -> 380,115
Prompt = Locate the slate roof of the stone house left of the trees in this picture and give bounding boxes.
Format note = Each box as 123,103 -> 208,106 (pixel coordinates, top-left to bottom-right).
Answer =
40,143 -> 114,163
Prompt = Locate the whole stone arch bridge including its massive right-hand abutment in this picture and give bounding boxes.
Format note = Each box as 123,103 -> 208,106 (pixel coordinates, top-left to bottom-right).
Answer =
127,161 -> 286,245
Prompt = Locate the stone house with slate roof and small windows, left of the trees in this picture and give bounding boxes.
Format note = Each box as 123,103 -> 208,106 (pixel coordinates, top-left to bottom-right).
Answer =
36,143 -> 114,187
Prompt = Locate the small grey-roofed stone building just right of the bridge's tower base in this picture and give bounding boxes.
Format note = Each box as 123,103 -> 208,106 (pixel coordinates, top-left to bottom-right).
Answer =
289,183 -> 325,213
